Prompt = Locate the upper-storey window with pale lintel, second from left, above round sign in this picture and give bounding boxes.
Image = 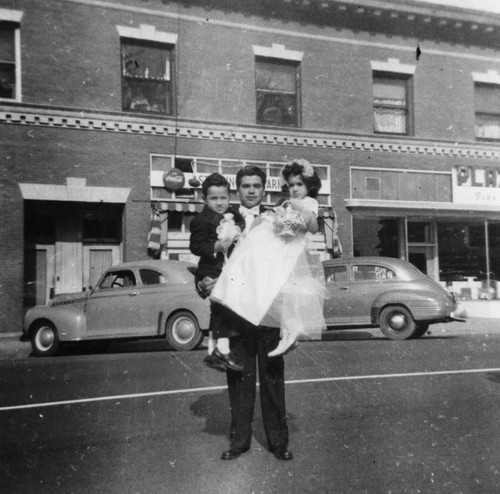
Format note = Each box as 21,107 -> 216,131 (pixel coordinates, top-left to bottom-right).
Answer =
117,24 -> 177,115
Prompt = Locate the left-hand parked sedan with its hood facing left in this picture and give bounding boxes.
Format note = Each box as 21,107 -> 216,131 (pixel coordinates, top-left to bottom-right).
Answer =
23,260 -> 210,356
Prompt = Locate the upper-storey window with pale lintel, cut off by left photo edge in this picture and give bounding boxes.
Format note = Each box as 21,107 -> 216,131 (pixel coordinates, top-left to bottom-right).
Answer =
0,9 -> 23,101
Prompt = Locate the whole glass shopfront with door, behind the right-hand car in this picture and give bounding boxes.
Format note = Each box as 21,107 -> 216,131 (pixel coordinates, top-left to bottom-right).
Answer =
353,218 -> 500,300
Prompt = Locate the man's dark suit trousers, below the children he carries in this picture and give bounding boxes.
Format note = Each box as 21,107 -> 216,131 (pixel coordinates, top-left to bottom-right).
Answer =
227,315 -> 288,451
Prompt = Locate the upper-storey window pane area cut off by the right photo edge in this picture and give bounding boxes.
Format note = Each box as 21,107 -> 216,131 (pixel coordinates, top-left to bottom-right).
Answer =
474,83 -> 500,140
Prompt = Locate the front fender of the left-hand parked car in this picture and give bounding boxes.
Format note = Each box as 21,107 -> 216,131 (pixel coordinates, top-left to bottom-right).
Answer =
24,305 -> 87,341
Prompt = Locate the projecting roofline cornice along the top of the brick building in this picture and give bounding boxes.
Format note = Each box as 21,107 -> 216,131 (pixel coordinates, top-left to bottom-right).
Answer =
61,0 -> 500,46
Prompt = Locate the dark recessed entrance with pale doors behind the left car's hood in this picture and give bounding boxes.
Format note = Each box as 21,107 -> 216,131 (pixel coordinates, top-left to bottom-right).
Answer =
24,201 -> 123,307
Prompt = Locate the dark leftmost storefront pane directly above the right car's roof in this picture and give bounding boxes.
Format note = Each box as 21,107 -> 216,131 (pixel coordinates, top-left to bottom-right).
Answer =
353,218 -> 399,257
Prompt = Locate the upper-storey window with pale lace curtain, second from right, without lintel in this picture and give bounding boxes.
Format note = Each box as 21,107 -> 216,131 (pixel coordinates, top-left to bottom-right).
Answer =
373,74 -> 410,135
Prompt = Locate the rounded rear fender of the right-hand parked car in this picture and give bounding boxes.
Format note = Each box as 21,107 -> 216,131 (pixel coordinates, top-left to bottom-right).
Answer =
371,290 -> 453,324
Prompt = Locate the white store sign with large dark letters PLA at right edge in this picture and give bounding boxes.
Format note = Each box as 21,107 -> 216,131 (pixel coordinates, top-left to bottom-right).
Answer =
452,165 -> 500,206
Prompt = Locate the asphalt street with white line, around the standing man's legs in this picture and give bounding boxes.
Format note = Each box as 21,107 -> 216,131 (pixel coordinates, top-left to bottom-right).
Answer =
0,321 -> 500,494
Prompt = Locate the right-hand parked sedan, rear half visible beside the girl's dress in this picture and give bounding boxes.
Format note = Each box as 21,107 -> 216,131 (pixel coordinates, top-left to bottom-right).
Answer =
323,257 -> 465,340
